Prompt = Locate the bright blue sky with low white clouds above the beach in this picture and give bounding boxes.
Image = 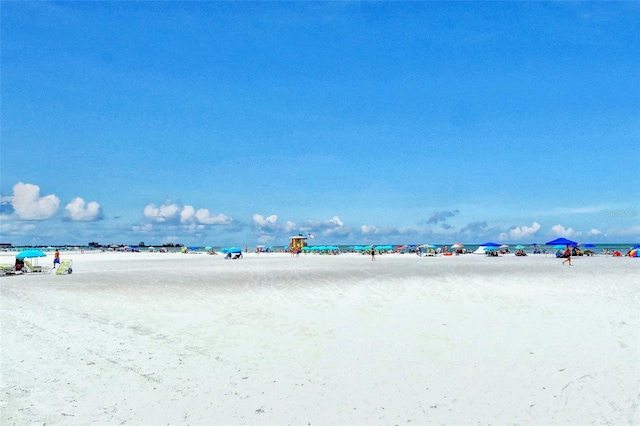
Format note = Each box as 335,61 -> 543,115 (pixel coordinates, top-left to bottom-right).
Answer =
0,2 -> 640,245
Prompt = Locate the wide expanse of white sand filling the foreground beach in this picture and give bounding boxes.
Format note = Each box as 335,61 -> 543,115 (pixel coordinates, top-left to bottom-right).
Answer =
0,252 -> 640,425
